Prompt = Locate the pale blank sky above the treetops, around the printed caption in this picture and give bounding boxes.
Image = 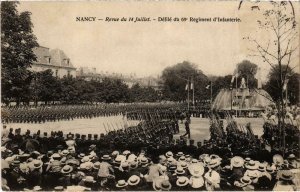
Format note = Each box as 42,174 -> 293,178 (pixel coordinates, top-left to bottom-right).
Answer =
19,1 -> 299,76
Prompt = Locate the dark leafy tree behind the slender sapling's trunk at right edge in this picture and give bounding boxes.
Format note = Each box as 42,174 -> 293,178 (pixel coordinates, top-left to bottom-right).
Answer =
264,65 -> 300,105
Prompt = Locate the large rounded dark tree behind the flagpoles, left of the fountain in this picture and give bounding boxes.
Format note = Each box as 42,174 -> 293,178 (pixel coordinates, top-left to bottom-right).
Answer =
162,61 -> 209,101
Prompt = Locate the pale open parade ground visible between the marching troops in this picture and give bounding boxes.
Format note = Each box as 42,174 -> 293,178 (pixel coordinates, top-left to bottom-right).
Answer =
7,115 -> 264,141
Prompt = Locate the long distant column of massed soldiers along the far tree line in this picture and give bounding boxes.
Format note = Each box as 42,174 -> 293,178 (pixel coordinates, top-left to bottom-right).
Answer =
1,103 -> 212,123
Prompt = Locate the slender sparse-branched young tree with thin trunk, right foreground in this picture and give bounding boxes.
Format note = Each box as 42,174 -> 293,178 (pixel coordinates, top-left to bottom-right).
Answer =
246,1 -> 299,152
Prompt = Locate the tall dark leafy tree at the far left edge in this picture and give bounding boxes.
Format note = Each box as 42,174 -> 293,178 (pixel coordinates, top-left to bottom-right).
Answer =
1,1 -> 38,105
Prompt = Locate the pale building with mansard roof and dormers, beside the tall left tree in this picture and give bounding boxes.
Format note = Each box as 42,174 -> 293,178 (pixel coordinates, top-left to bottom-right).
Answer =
30,46 -> 76,78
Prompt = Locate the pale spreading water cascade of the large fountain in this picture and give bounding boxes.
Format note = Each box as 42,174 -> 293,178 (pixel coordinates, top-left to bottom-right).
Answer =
212,89 -> 273,110
